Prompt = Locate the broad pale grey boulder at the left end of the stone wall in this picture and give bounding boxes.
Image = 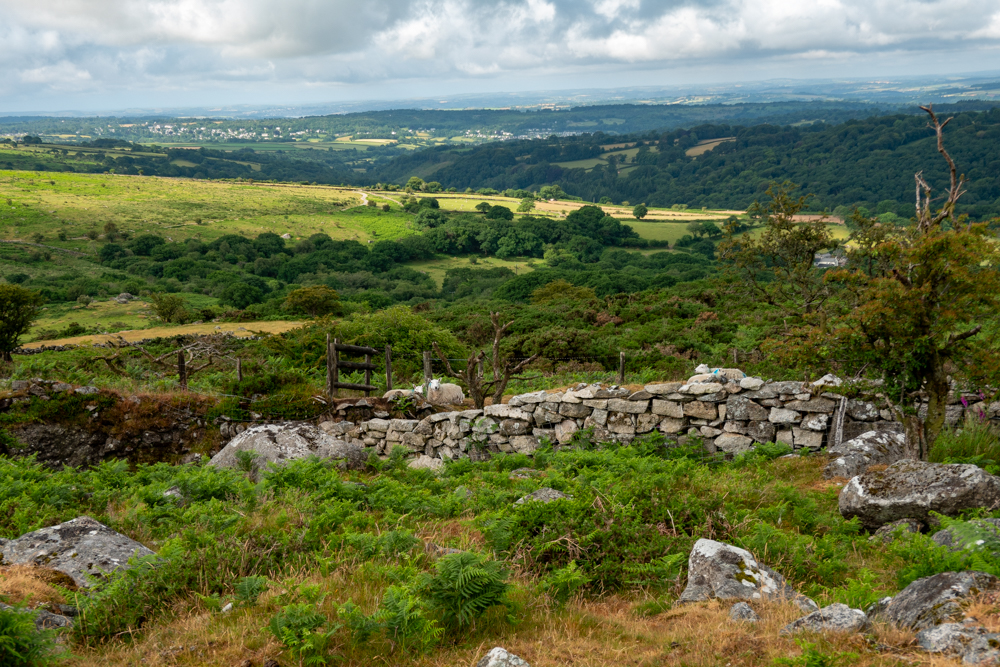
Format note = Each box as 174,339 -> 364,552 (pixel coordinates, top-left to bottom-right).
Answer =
208,420 -> 375,469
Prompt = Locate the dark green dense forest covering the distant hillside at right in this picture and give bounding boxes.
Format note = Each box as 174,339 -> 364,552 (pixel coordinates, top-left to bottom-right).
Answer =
376,109 -> 1000,218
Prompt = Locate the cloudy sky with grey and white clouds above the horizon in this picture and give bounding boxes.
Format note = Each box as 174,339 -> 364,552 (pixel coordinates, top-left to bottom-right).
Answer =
0,0 -> 1000,112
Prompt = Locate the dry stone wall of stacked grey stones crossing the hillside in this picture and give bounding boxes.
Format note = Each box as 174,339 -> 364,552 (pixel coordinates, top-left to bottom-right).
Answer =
320,369 -> 1000,460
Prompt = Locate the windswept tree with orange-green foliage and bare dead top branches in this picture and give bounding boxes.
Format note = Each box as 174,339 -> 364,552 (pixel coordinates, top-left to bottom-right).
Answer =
776,106 -> 1000,458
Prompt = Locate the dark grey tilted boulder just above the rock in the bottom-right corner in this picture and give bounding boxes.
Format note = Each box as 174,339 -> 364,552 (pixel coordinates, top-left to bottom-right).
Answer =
884,572 -> 1000,630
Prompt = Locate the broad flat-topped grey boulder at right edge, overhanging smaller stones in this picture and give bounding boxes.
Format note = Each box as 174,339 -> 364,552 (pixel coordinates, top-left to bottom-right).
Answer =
840,459 -> 1000,530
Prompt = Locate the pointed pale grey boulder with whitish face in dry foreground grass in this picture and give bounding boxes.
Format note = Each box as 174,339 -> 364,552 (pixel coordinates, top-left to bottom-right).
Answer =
678,539 -> 818,611
